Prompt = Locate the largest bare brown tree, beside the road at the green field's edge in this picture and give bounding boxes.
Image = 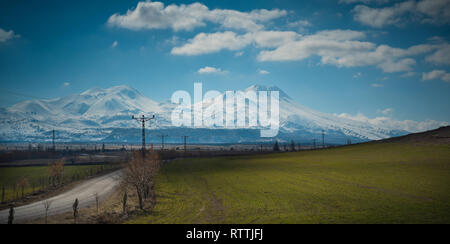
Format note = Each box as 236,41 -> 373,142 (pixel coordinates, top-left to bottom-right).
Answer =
124,151 -> 160,210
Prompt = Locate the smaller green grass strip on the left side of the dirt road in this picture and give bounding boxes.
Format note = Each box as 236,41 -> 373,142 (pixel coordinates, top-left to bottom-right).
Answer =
0,165 -> 118,201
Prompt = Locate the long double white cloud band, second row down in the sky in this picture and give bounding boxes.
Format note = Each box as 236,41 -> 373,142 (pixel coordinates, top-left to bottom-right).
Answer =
171,30 -> 445,73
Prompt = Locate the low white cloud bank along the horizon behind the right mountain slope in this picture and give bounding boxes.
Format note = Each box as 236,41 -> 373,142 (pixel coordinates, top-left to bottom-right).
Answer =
336,113 -> 449,132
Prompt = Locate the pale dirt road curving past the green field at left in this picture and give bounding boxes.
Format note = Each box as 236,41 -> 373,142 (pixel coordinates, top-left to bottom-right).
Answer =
0,171 -> 122,224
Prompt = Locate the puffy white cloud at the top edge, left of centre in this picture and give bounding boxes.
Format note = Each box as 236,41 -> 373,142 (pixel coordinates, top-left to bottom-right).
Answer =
108,1 -> 287,31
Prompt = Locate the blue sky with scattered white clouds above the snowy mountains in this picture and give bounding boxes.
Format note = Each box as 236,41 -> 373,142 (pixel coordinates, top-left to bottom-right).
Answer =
0,0 -> 450,126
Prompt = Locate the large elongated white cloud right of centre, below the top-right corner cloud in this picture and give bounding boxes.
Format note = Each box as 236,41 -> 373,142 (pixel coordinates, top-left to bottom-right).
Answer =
258,30 -> 438,73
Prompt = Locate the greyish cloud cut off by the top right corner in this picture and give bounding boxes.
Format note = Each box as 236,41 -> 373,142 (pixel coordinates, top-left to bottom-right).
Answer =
352,0 -> 450,28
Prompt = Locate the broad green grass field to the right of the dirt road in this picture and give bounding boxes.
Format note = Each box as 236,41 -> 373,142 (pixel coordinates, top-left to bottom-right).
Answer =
130,143 -> 450,223
